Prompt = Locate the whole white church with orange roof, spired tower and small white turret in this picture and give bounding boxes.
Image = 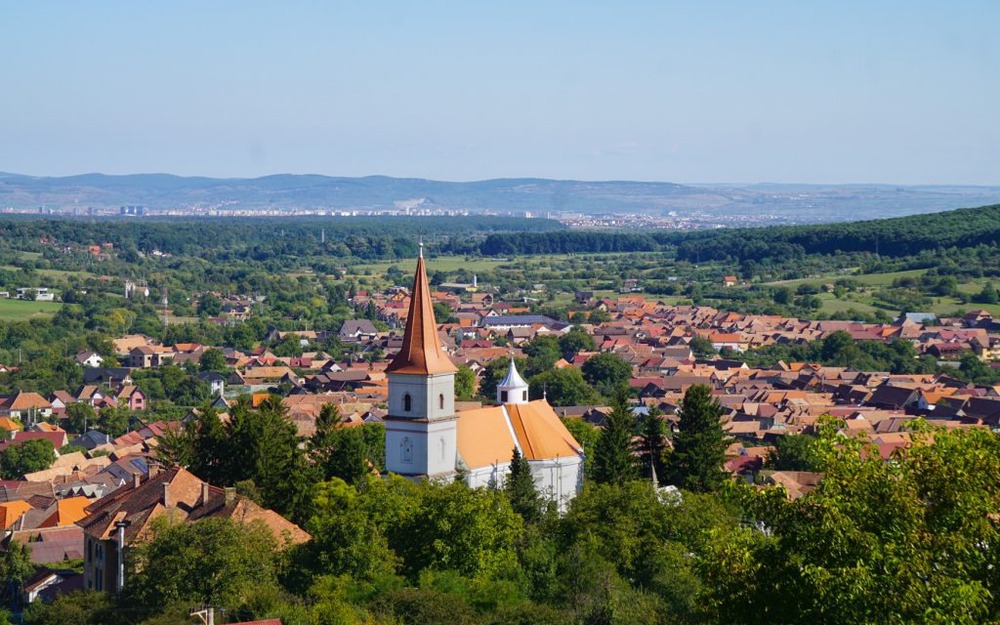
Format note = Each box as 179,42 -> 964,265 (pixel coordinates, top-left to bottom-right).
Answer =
385,246 -> 583,510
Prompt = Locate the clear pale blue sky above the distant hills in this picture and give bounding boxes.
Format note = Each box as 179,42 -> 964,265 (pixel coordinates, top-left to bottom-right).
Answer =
0,0 -> 1000,185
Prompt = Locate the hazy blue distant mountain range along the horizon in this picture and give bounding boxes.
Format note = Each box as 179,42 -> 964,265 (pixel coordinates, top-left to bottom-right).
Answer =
0,173 -> 1000,225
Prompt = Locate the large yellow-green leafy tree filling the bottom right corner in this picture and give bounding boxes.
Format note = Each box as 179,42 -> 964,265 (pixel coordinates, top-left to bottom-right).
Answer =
702,423 -> 1000,624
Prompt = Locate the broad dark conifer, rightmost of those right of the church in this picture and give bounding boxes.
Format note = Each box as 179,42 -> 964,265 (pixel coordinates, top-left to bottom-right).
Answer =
667,384 -> 727,493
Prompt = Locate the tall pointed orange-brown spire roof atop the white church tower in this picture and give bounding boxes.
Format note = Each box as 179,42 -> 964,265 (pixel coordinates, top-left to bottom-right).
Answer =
385,251 -> 457,375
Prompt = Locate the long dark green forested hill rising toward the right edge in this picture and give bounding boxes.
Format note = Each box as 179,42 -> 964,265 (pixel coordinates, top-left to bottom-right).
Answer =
480,204 -> 1000,262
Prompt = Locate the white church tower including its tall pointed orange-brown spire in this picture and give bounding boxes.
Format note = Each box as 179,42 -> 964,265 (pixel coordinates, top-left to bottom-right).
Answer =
385,245 -> 458,477
